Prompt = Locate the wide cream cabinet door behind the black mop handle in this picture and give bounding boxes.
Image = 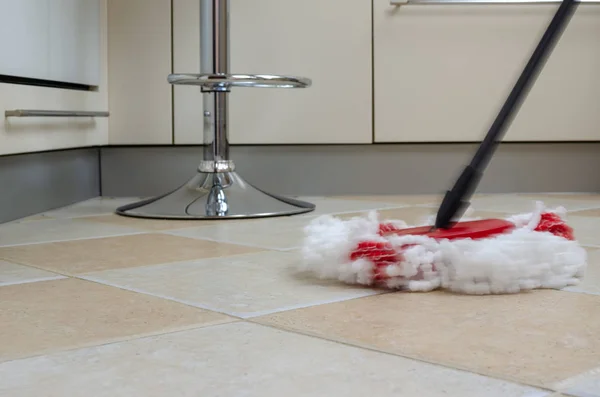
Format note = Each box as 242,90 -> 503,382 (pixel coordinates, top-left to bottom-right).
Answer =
374,0 -> 600,142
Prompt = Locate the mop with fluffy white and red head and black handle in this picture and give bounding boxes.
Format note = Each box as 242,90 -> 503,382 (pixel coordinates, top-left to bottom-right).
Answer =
300,0 -> 587,295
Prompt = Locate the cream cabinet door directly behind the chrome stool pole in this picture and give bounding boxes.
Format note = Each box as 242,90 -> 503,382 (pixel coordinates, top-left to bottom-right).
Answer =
173,0 -> 372,144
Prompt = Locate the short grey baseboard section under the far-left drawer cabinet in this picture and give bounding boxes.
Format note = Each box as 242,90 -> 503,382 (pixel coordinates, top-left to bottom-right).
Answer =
0,148 -> 100,223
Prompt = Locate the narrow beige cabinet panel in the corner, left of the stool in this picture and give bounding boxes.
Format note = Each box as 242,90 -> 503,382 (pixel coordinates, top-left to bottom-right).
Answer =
108,0 -> 173,145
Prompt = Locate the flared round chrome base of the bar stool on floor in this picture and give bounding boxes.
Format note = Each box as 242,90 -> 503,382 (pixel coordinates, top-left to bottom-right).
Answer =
117,172 -> 315,220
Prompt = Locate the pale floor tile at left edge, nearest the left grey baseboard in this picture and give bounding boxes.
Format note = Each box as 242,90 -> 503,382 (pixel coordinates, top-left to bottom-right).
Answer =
0,219 -> 143,247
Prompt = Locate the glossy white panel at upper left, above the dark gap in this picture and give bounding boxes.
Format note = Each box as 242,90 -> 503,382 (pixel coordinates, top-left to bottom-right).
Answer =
0,0 -> 102,86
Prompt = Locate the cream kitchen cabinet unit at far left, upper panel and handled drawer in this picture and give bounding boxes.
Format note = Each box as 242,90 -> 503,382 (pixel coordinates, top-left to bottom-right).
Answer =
0,0 -> 108,155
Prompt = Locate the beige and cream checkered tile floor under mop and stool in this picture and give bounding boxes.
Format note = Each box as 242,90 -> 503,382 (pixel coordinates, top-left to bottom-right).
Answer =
0,194 -> 600,397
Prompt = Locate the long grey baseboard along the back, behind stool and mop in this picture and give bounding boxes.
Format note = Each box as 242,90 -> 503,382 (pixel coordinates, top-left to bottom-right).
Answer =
101,142 -> 600,196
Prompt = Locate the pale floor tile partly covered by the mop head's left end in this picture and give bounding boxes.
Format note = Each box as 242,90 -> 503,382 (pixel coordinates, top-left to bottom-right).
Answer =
84,252 -> 378,317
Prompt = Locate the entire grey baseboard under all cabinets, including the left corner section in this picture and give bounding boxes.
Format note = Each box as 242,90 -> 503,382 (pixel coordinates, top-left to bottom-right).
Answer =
0,142 -> 600,223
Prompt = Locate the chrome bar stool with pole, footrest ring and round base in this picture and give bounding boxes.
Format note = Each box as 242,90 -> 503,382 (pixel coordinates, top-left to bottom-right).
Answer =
116,0 -> 315,219
